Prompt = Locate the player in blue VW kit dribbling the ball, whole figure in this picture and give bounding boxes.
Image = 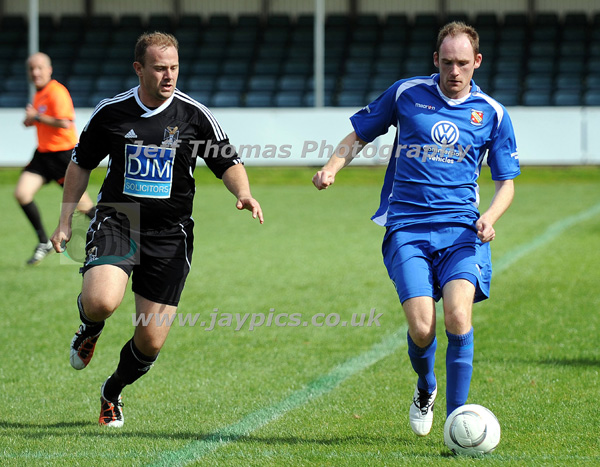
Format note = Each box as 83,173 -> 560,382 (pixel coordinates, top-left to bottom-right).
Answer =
313,22 -> 520,436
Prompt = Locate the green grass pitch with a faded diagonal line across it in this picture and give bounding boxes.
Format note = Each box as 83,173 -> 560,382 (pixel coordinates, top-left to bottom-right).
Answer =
0,167 -> 600,466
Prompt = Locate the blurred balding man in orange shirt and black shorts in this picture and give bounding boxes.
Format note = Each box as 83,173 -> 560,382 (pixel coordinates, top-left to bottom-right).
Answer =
15,53 -> 94,265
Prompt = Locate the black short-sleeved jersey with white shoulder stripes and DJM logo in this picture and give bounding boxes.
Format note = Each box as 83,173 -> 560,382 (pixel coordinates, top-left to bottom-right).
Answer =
72,87 -> 240,230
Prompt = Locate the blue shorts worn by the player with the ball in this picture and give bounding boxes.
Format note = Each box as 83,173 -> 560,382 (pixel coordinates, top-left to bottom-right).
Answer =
382,224 -> 492,303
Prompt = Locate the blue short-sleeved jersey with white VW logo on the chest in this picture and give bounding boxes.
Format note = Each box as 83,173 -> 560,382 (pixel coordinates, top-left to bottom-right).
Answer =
350,74 -> 520,226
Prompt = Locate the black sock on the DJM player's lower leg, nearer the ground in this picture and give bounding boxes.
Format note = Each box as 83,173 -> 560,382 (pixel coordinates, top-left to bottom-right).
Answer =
104,338 -> 158,402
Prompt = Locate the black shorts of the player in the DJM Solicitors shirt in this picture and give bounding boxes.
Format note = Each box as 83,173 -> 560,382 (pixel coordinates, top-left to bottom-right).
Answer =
80,209 -> 194,306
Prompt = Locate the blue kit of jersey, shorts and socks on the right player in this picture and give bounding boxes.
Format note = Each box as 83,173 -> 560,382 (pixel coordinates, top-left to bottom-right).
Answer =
350,74 -> 520,414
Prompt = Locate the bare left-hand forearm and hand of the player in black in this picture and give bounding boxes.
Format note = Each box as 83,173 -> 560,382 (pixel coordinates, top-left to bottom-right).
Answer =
50,162 -> 91,253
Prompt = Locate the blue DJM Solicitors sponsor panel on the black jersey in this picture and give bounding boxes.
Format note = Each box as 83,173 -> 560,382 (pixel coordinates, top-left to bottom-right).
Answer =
123,144 -> 175,198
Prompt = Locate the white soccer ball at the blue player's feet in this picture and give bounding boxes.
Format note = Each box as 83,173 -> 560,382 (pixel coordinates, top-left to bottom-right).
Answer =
444,404 -> 500,457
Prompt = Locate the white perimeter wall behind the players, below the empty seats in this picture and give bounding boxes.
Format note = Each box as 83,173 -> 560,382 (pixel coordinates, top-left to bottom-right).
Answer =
0,107 -> 600,167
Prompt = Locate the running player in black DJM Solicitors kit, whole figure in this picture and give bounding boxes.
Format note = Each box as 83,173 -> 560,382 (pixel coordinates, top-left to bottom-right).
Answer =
52,32 -> 263,427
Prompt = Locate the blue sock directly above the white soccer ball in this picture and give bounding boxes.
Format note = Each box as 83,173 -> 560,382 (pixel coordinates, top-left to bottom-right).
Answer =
446,328 -> 474,416
